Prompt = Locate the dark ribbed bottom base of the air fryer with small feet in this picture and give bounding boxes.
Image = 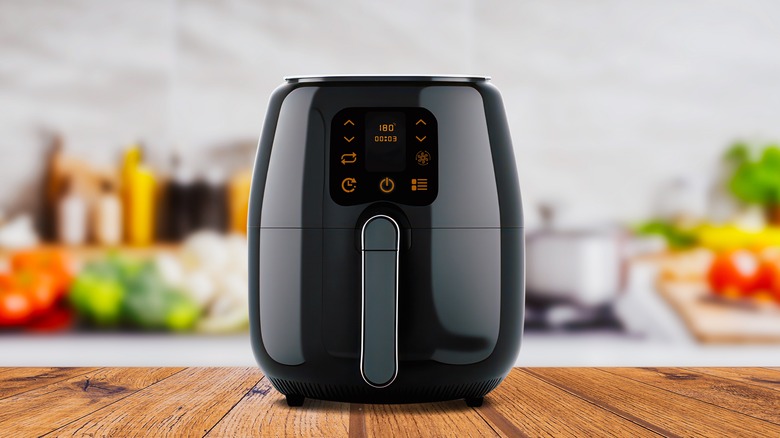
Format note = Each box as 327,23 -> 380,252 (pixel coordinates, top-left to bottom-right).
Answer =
270,377 -> 504,406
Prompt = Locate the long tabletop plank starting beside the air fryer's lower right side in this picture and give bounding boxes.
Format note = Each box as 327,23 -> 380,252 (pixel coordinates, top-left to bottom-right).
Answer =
527,368 -> 780,436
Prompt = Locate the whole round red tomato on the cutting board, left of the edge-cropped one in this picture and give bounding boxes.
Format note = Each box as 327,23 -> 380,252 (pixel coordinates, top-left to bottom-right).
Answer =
708,250 -> 775,297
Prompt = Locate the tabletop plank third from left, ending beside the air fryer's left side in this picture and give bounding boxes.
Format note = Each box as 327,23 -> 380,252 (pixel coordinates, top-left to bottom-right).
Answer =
51,368 -> 263,437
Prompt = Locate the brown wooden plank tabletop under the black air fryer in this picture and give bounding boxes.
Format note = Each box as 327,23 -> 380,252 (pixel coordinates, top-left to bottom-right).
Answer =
0,368 -> 780,437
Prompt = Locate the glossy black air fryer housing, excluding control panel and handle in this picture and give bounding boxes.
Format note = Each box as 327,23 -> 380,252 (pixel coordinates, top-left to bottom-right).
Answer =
248,76 -> 524,403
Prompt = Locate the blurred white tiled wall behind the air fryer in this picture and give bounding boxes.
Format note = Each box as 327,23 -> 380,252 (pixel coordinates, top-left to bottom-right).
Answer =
0,0 -> 780,223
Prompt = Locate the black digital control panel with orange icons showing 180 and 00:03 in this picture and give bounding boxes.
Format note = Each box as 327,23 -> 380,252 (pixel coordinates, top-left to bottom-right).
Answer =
329,108 -> 439,205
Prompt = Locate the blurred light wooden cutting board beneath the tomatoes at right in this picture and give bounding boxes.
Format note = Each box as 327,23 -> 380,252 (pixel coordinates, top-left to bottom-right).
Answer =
658,280 -> 780,344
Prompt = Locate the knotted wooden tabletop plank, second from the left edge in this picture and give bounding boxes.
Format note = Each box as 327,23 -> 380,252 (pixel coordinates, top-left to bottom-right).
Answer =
0,368 -> 180,436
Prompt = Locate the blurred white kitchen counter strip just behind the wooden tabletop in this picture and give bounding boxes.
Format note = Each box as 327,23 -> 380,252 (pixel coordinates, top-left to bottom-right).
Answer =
0,332 -> 780,367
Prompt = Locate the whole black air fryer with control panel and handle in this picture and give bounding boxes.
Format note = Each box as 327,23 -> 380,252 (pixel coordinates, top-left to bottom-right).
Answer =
249,76 -> 524,406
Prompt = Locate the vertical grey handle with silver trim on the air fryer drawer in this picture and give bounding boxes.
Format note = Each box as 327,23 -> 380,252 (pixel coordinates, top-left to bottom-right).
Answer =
360,215 -> 400,388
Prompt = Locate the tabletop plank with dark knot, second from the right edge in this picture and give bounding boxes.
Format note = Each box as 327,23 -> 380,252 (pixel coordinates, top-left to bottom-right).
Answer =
603,368 -> 780,424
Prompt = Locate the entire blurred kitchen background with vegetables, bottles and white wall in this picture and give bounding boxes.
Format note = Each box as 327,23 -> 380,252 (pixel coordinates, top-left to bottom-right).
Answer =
0,0 -> 780,366
